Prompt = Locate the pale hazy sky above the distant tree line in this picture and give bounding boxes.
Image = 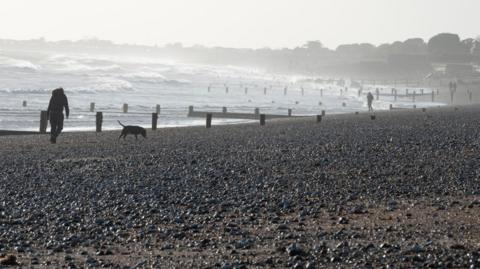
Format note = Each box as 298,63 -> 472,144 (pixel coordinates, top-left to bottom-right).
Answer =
0,0 -> 480,48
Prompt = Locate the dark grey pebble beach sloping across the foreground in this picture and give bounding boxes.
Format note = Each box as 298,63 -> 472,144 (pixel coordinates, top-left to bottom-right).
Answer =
0,106 -> 480,269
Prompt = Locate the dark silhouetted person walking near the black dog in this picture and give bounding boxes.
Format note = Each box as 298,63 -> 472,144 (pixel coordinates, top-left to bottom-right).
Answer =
47,88 -> 70,144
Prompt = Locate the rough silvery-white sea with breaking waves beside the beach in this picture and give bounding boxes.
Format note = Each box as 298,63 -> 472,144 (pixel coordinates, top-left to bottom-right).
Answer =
0,50 -> 443,131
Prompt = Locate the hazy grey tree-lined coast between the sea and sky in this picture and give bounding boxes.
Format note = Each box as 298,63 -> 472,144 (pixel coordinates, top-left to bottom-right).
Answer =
0,33 -> 480,76
